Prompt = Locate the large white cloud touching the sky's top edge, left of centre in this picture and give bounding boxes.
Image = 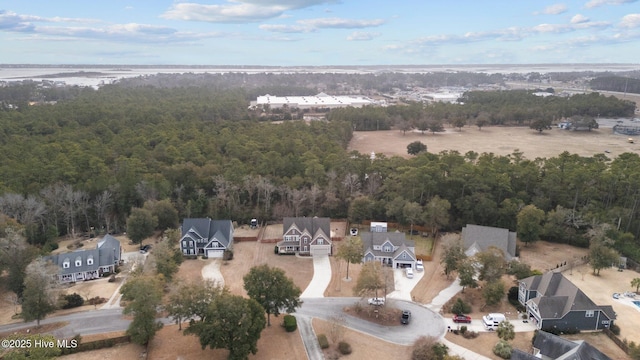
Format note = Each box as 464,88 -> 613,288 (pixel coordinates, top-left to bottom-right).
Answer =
161,0 -> 334,23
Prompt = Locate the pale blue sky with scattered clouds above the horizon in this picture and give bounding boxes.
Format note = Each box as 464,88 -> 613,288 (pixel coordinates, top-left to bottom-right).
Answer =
0,0 -> 640,66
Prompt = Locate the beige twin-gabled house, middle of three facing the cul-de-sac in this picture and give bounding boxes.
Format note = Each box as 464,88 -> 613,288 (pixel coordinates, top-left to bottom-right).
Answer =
276,217 -> 332,256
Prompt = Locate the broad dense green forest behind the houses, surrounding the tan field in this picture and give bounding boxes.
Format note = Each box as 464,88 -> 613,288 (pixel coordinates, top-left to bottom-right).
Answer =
0,81 -> 640,264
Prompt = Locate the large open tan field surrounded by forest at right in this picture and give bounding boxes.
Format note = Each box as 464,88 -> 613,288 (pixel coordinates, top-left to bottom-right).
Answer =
348,126 -> 640,159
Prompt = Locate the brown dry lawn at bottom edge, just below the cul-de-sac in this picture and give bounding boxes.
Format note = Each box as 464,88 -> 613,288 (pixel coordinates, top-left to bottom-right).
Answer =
314,319 -> 411,360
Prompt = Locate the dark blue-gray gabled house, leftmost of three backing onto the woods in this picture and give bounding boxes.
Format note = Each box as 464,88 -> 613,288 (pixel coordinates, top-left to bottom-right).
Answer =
180,218 -> 233,258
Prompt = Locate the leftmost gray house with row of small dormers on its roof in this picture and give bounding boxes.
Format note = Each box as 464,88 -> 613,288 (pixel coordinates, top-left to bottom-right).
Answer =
45,235 -> 122,282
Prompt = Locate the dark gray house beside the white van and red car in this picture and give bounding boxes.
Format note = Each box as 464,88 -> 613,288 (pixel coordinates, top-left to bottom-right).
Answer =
518,271 -> 616,331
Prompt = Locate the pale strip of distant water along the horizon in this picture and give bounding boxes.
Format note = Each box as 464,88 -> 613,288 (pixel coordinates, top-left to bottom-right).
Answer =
0,64 -> 640,87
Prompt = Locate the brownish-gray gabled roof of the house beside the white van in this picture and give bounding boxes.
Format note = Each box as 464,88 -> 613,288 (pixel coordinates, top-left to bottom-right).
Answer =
521,271 -> 616,319
